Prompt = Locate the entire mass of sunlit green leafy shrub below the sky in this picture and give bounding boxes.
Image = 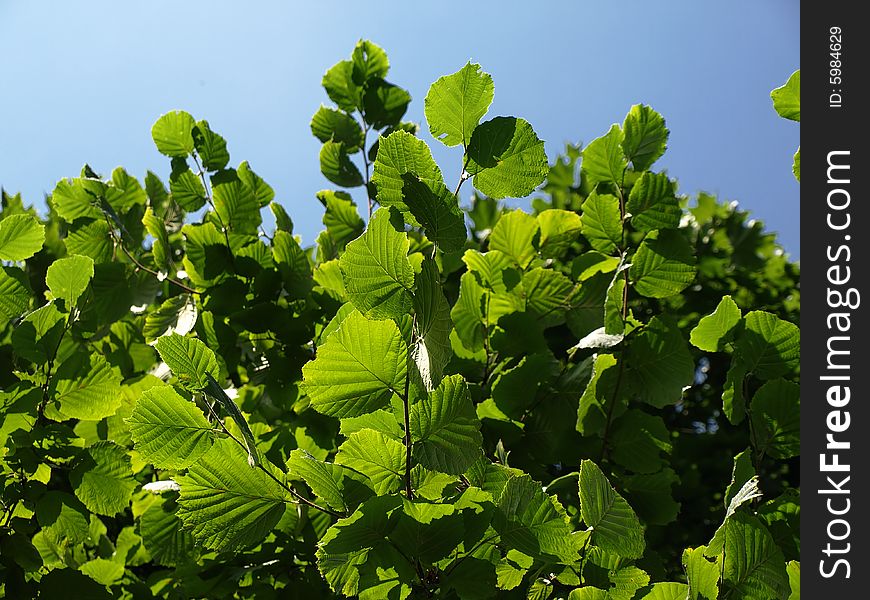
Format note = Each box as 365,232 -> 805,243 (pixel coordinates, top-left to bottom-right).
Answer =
0,41 -> 800,600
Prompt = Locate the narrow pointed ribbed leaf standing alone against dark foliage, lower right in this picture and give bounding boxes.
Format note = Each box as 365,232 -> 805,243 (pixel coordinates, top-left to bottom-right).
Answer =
580,460 -> 646,558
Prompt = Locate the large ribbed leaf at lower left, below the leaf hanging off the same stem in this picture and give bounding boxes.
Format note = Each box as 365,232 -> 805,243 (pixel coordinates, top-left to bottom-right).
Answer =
176,439 -> 286,551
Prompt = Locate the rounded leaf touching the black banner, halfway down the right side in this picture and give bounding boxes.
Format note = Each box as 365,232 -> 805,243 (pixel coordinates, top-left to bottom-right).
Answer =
735,310 -> 801,379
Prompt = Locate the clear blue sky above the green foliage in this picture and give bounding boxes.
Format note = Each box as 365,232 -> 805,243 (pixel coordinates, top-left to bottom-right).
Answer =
0,0 -> 800,257
